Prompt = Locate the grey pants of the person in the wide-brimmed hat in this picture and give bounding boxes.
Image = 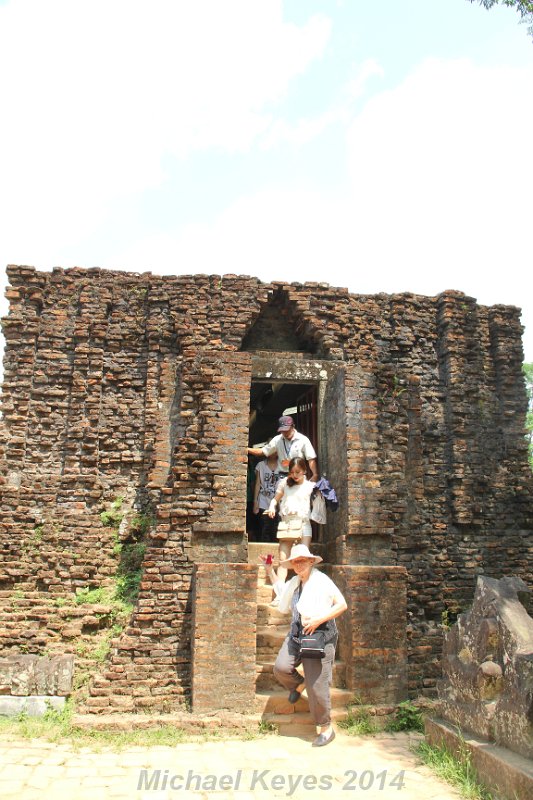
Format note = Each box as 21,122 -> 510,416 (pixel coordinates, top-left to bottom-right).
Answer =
274,636 -> 335,725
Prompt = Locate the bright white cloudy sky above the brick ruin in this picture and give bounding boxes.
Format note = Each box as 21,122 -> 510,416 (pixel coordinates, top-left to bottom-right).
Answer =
0,0 -> 533,361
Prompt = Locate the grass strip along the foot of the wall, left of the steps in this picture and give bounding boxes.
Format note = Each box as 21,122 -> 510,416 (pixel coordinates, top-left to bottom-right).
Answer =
0,701 -> 269,751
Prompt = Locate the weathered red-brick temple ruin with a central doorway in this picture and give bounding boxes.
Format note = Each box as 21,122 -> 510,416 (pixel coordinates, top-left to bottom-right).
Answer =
0,266 -> 533,713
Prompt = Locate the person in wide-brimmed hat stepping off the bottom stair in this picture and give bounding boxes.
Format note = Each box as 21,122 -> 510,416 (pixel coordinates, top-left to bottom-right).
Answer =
259,544 -> 347,747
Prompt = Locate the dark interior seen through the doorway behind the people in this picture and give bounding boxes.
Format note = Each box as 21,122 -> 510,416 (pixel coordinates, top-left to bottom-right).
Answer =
246,381 -> 319,541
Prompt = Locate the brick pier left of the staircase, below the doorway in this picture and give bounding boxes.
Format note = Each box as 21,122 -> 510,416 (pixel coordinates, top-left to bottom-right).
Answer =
192,563 -> 257,714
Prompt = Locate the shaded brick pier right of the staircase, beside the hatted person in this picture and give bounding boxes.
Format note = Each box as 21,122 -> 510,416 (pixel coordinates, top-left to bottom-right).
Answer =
331,566 -> 407,705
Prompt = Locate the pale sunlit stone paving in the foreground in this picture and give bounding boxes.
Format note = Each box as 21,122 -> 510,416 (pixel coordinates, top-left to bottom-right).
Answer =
0,732 -> 459,800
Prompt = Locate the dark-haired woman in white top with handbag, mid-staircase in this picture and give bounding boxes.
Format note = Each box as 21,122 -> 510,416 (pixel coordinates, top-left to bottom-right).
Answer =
267,457 -> 315,581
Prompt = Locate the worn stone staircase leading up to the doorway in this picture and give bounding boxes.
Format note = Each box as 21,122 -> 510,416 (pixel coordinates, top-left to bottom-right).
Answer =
248,542 -> 353,733
